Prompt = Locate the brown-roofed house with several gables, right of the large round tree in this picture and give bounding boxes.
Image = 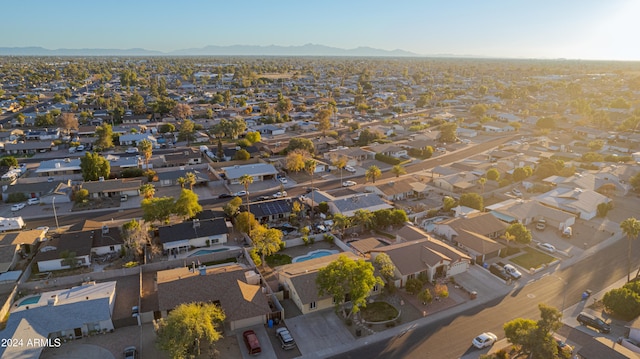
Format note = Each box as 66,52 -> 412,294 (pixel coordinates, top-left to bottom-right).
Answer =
370,226 -> 471,288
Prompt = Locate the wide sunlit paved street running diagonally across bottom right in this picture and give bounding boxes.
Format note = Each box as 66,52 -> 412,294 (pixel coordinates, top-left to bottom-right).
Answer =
332,235 -> 640,359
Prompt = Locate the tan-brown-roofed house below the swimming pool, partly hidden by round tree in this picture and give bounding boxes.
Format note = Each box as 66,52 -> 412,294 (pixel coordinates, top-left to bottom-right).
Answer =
276,252 -> 380,314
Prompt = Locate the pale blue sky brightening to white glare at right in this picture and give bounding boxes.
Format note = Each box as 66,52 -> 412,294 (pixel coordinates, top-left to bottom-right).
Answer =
0,0 -> 640,60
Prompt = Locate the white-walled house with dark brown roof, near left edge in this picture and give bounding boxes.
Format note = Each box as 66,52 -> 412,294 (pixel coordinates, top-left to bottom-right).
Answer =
33,232 -> 92,272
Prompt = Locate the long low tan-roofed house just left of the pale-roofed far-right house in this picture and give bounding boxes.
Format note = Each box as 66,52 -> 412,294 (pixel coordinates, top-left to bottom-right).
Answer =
485,199 -> 576,230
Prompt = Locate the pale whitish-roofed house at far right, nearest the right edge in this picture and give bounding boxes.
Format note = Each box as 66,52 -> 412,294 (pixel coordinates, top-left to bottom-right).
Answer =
534,187 -> 611,221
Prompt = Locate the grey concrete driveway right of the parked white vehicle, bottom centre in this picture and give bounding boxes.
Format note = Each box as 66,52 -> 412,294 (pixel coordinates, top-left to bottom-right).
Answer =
286,309 -> 355,355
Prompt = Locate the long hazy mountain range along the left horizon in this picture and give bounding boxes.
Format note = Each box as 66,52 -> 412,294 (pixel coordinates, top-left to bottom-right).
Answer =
0,44 -> 422,57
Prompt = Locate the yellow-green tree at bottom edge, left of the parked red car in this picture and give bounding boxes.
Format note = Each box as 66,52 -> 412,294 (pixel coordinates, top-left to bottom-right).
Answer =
157,303 -> 225,359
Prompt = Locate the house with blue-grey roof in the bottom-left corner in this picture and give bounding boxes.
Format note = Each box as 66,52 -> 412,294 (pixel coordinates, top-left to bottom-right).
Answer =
0,281 -> 116,359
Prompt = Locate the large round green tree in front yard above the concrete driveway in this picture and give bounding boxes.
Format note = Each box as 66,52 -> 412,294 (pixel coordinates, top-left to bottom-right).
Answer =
316,254 -> 384,315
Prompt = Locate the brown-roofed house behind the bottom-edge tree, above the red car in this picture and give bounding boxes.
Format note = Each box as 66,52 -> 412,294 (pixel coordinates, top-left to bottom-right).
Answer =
157,264 -> 271,331
